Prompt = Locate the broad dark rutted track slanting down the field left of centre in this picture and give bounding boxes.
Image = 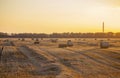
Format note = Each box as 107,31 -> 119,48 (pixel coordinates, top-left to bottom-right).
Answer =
19,46 -> 61,75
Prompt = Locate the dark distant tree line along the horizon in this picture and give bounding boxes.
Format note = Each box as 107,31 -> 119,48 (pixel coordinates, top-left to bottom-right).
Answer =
0,32 -> 120,38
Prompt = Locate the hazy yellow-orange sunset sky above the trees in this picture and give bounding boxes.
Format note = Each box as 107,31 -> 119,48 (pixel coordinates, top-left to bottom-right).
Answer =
0,0 -> 120,33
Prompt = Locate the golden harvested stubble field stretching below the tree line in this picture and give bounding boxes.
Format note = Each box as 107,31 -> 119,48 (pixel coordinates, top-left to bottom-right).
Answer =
0,38 -> 120,78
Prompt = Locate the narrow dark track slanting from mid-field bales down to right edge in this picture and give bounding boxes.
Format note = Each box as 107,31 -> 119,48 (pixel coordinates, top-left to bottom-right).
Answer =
66,49 -> 120,71
